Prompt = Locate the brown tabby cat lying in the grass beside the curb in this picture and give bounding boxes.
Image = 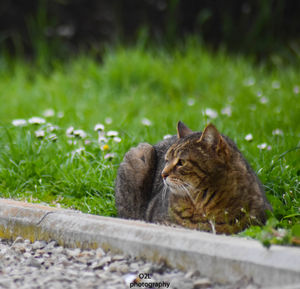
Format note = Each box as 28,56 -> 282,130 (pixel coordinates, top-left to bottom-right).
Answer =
115,121 -> 272,234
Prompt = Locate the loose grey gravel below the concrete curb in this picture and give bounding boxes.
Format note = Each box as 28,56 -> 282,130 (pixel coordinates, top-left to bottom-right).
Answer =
0,237 -> 260,289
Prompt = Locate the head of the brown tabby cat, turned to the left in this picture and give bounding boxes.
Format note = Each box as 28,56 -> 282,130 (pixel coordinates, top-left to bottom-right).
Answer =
162,122 -> 233,195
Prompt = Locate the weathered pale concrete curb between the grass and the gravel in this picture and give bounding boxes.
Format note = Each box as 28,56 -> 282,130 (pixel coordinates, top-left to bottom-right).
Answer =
0,199 -> 300,286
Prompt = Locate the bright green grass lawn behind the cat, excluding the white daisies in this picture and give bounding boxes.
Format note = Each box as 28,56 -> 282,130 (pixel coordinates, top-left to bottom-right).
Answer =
0,43 -> 300,245
